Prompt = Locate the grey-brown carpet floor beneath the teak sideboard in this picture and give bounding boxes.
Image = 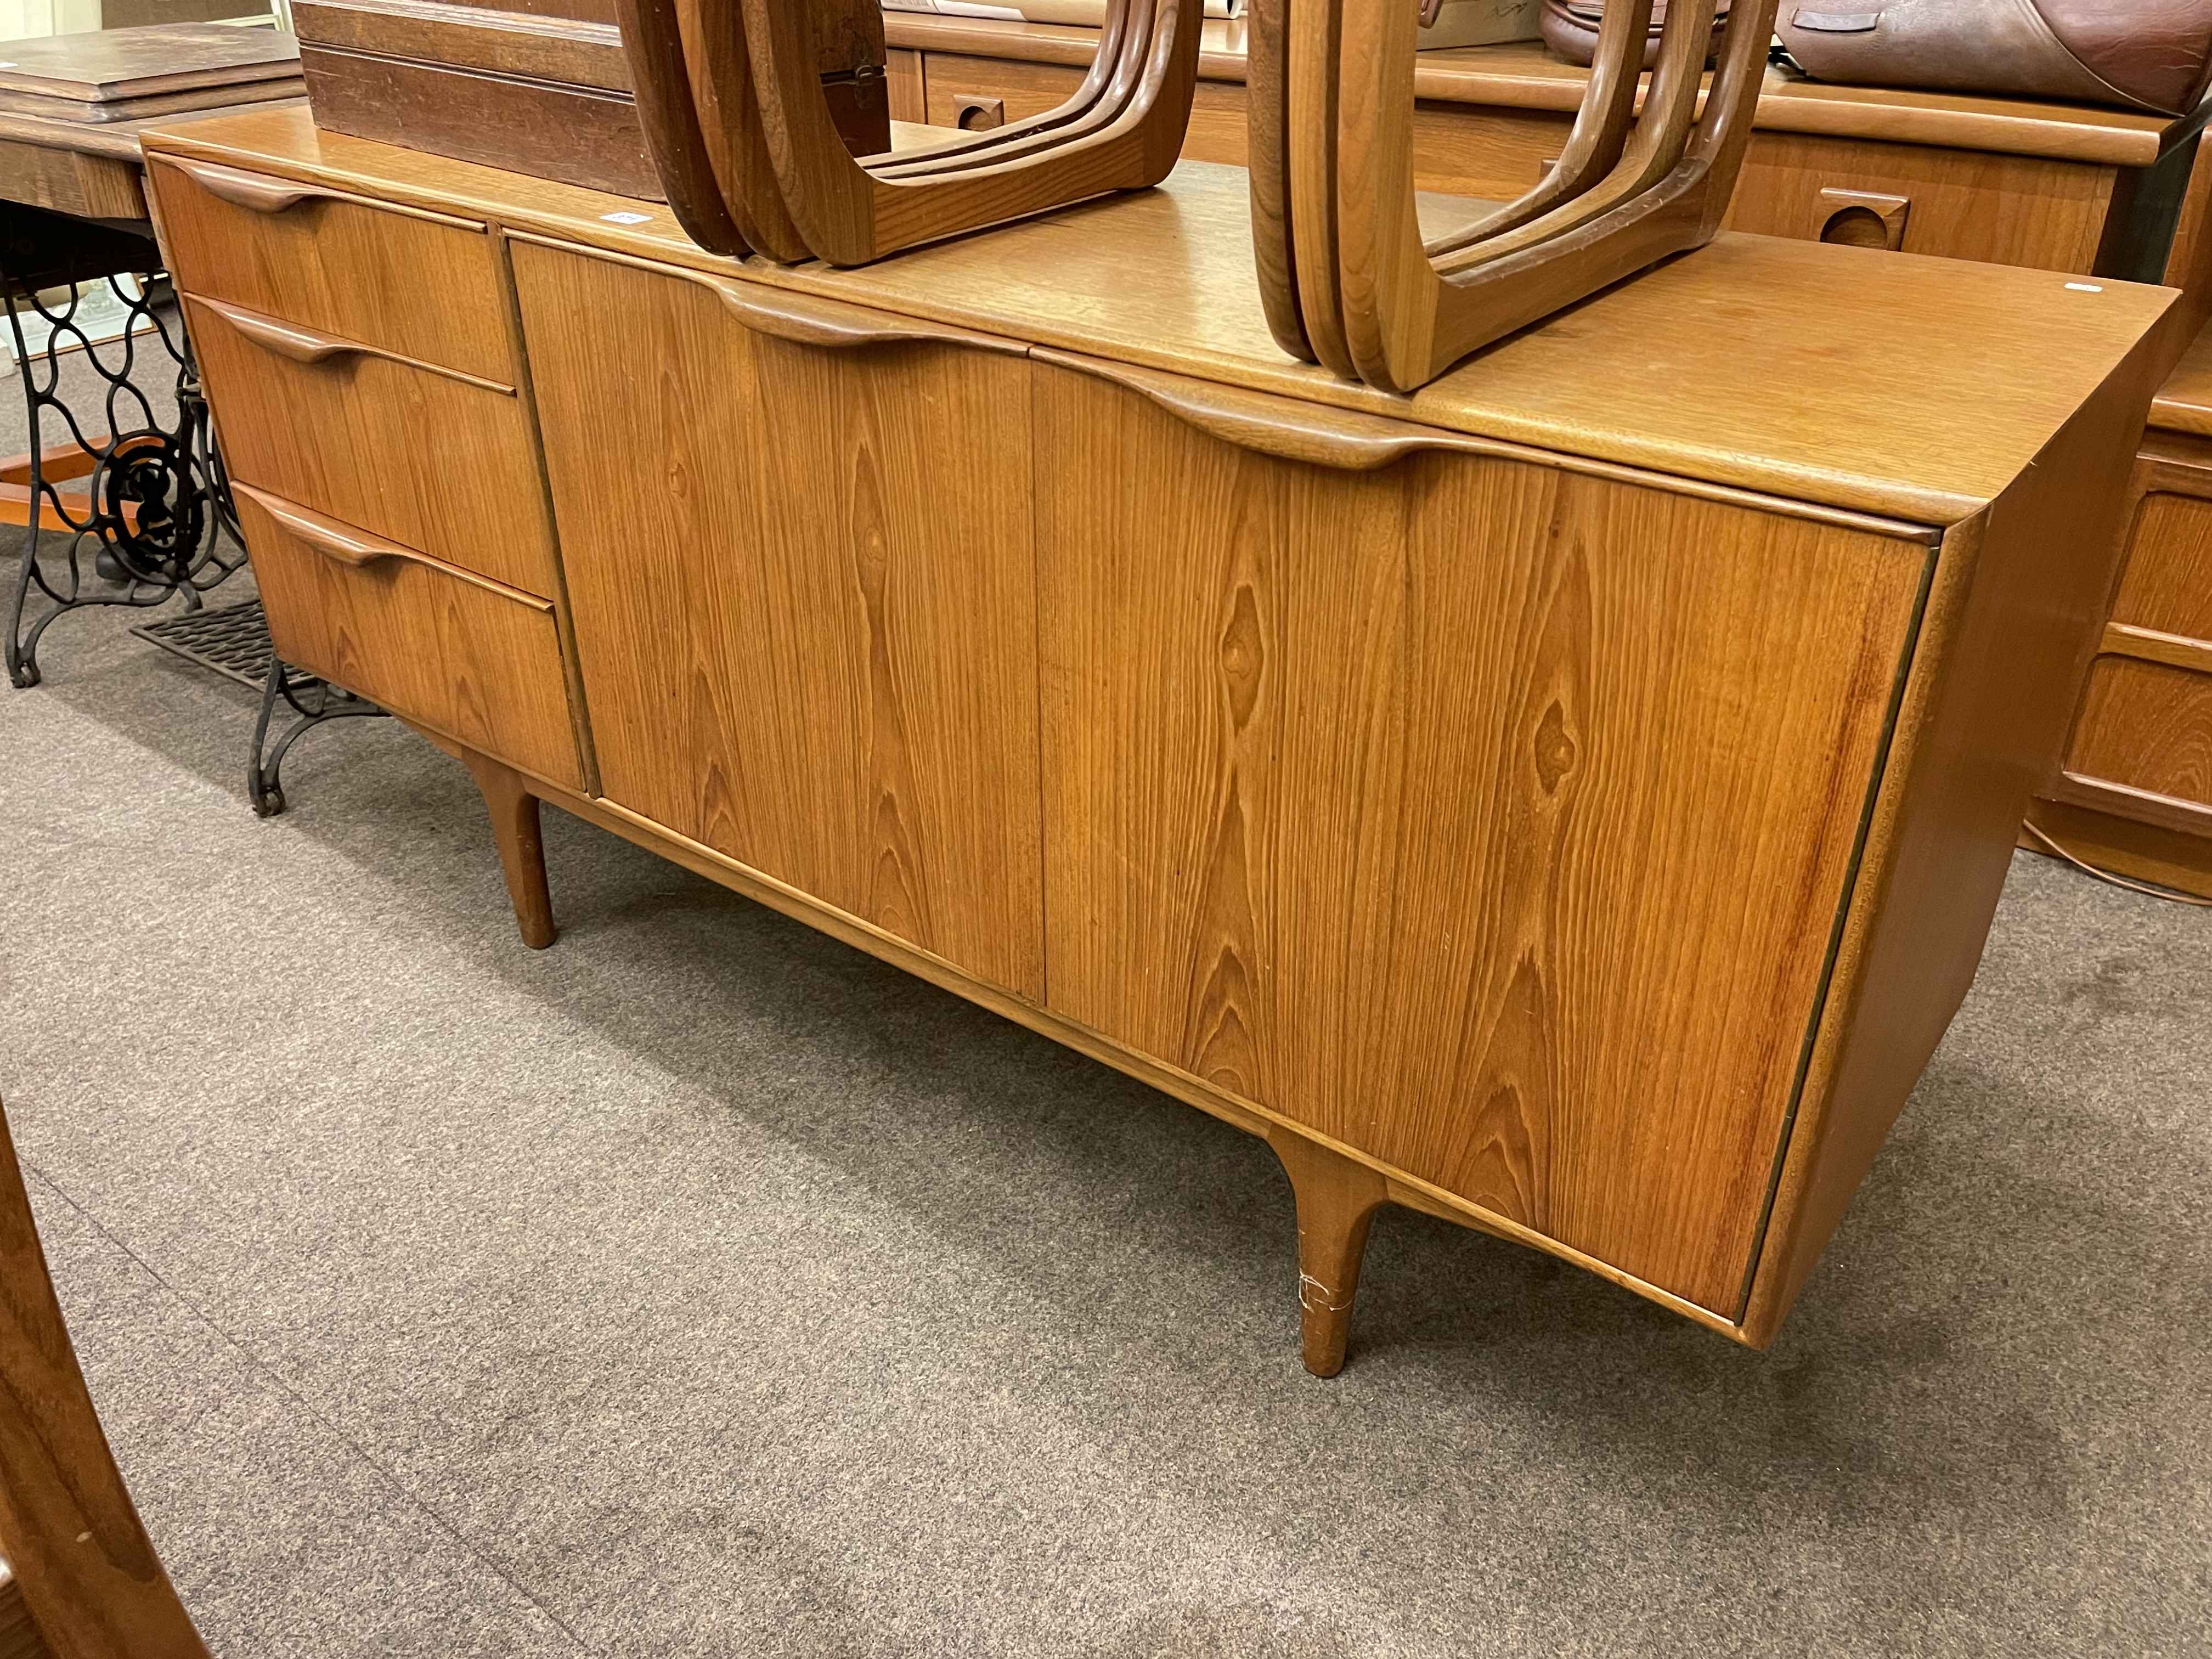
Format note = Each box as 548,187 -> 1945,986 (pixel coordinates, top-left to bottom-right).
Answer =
0,436 -> 2212,1659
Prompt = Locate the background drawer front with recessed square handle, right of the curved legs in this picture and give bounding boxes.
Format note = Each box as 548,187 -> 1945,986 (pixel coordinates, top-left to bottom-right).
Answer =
1728,133 -> 2117,272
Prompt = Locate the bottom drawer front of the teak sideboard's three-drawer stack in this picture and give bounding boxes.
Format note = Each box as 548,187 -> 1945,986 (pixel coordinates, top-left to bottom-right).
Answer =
236,484 -> 584,789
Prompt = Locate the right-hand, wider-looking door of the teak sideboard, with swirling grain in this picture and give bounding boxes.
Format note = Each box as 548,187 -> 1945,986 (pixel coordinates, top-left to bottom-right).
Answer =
1035,365 -> 1929,1310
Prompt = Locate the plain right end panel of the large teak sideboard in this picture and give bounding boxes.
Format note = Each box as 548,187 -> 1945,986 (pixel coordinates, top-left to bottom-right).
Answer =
1743,312 -> 2176,1345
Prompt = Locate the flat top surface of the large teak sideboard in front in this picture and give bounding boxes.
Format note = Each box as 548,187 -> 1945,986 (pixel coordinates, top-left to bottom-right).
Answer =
146,106 -> 2176,527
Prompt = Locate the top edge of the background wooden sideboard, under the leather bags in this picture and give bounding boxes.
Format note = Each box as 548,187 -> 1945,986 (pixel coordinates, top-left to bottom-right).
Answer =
883,11 -> 2203,168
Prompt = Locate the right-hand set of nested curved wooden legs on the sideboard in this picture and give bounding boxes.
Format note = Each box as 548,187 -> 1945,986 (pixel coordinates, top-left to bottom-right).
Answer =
1250,0 -> 1776,392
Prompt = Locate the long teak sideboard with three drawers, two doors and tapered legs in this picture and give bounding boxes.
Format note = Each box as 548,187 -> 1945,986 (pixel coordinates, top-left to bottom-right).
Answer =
148,113 -> 2183,1374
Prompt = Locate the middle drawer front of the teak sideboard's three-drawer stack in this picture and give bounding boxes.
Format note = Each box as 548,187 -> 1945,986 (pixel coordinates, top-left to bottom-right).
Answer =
186,294 -> 555,597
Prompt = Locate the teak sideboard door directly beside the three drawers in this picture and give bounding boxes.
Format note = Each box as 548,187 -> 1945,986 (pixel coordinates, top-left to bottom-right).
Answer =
513,241 -> 1044,997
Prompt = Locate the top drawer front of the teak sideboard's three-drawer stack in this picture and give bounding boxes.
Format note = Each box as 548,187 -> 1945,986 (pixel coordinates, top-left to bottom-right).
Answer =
148,157 -> 515,383
